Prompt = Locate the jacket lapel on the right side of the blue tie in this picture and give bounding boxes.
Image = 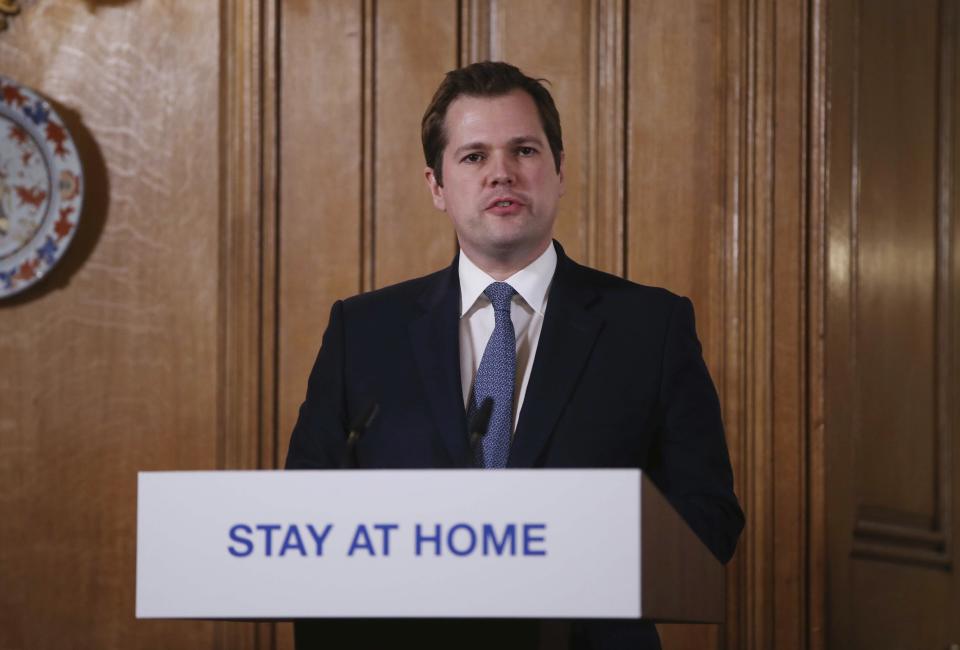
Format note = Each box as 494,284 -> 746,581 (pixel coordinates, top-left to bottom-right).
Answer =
507,244 -> 603,467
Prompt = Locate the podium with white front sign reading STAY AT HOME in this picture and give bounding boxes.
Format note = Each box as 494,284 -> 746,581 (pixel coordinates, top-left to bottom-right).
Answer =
136,469 -> 724,622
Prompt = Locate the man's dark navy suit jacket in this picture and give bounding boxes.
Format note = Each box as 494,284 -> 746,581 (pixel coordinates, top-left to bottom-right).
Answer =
286,244 -> 744,648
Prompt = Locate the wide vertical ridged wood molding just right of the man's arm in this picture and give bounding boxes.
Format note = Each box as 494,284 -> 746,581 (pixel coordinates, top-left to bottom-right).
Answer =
723,0 -> 823,649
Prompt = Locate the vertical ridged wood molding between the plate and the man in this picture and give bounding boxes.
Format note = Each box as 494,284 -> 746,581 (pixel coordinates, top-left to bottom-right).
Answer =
214,0 -> 280,650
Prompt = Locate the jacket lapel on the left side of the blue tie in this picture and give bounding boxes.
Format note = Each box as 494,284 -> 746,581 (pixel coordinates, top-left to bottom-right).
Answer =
410,259 -> 470,466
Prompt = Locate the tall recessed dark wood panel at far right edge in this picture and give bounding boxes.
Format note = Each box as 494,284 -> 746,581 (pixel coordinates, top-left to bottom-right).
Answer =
850,2 -> 938,528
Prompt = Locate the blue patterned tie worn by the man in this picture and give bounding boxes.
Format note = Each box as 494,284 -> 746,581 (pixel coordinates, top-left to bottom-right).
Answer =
470,282 -> 517,467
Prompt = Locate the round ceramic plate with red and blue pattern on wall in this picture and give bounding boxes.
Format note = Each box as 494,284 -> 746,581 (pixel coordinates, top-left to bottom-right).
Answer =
0,76 -> 83,298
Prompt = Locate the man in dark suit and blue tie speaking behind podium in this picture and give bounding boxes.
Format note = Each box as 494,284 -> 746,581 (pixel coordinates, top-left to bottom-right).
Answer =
287,62 -> 743,648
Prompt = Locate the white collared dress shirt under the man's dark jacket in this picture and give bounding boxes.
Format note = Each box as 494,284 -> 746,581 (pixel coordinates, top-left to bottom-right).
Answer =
459,243 -> 557,431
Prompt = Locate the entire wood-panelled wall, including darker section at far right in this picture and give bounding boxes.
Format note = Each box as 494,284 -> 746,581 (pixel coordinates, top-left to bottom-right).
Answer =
0,0 -> 960,650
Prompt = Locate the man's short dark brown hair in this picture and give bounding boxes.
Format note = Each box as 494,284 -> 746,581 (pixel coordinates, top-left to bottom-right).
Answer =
420,61 -> 563,186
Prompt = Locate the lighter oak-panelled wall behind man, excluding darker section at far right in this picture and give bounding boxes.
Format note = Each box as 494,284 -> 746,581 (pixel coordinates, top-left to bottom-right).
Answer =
0,0 -> 810,648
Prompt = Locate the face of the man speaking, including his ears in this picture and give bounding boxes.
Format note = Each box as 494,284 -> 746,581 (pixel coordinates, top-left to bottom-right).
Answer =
425,90 -> 563,275
